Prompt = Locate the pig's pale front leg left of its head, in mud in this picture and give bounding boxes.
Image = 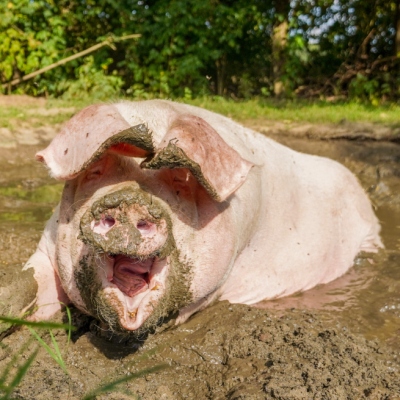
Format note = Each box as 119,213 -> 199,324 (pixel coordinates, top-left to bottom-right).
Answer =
23,206 -> 70,321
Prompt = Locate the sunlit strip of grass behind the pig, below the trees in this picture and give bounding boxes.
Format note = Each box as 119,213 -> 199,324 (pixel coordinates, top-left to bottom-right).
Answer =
0,96 -> 400,130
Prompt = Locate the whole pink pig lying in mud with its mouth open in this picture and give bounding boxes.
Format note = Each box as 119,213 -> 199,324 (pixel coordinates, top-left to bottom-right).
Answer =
24,100 -> 383,332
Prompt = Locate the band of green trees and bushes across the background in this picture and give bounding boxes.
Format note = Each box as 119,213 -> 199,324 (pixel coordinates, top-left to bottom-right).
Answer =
0,0 -> 400,100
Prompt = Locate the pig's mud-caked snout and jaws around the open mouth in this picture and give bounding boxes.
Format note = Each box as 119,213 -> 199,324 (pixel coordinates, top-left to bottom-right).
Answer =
73,185 -> 195,330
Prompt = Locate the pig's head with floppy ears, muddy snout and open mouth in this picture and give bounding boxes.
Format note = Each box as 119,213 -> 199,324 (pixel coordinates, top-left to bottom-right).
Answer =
36,103 -> 252,331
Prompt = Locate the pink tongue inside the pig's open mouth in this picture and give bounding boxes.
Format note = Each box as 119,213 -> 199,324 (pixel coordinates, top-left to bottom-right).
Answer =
112,255 -> 154,297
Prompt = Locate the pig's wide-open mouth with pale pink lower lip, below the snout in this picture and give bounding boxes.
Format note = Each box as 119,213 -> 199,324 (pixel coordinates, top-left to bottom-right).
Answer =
102,254 -> 169,330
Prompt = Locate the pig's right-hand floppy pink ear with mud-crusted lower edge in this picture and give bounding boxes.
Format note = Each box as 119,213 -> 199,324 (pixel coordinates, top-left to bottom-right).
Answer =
141,115 -> 253,201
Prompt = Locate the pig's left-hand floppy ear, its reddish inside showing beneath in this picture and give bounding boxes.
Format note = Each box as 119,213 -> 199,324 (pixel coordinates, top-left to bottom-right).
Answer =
36,105 -> 155,179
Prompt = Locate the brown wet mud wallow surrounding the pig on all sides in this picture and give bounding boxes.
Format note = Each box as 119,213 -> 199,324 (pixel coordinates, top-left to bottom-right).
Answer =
0,118 -> 400,399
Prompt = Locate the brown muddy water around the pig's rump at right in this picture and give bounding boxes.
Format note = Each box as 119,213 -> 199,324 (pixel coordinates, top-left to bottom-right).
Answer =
261,138 -> 400,348
